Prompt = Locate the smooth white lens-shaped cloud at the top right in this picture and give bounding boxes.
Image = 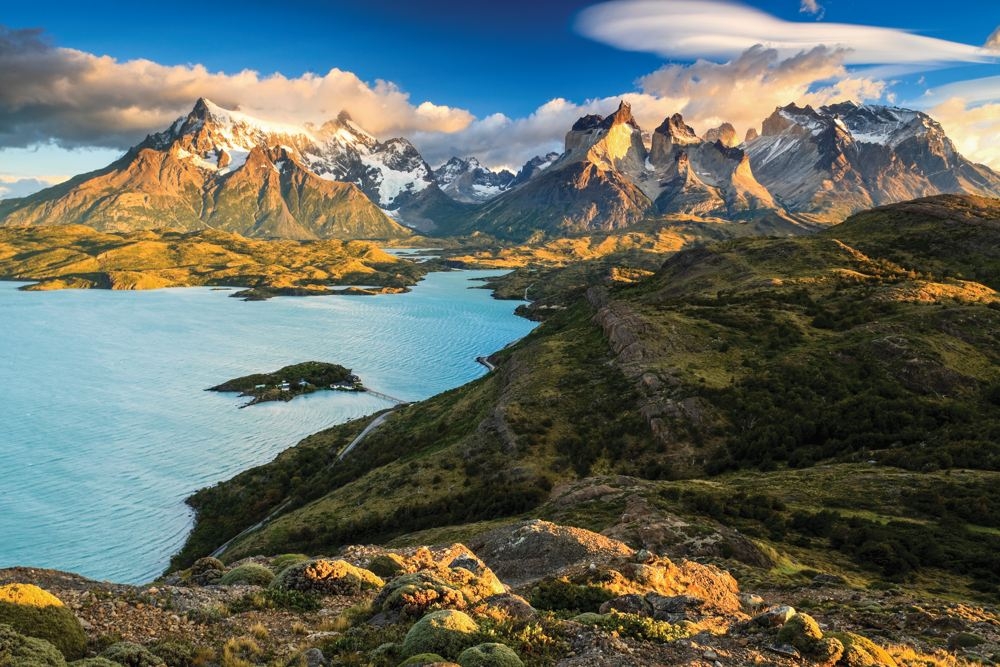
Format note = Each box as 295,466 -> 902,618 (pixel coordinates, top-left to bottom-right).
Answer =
577,0 -> 996,65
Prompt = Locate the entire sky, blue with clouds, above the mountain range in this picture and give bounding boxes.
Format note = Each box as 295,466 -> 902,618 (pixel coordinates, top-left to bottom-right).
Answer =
0,0 -> 1000,197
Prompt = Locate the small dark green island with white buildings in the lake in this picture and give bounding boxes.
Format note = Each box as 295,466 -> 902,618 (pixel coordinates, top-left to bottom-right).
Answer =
206,361 -> 367,408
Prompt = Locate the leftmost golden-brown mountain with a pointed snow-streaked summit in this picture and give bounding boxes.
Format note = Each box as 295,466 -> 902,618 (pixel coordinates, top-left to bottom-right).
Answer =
0,100 -> 410,239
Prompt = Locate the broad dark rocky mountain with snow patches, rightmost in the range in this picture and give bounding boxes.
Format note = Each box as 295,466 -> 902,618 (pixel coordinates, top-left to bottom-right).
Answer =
744,102 -> 1000,222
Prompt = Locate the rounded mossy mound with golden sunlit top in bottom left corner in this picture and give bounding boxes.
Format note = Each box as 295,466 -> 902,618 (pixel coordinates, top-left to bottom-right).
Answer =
0,584 -> 87,660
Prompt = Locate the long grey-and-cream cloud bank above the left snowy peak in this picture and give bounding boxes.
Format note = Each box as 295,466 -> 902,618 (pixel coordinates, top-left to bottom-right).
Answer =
0,26 -> 473,148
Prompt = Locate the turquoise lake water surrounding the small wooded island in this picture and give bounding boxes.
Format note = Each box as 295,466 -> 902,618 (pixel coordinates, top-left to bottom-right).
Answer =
0,271 -> 535,583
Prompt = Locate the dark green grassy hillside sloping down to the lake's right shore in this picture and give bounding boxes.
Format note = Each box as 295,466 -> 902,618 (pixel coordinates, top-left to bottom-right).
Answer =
175,193 -> 1000,597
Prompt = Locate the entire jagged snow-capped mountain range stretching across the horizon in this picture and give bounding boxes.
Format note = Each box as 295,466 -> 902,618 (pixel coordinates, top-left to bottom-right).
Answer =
0,99 -> 1000,240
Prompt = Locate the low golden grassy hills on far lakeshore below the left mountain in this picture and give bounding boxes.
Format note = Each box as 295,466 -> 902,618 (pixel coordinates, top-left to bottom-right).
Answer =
0,225 -> 426,294
